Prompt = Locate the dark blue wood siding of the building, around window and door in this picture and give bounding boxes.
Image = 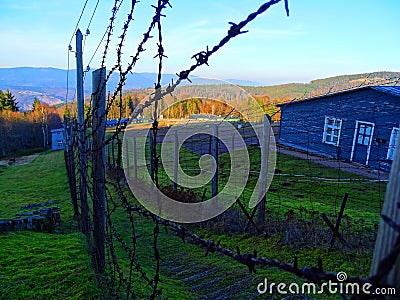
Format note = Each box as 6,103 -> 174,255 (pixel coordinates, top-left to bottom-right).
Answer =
279,88 -> 400,171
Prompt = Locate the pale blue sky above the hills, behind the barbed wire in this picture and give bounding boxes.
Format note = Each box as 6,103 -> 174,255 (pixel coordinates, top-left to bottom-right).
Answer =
0,0 -> 400,84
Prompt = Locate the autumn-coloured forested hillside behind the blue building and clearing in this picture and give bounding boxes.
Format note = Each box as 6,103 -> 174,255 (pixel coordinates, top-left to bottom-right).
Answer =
124,72 -> 400,121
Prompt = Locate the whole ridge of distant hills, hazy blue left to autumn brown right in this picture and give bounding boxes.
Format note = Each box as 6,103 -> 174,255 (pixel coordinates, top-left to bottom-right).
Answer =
0,67 -> 400,110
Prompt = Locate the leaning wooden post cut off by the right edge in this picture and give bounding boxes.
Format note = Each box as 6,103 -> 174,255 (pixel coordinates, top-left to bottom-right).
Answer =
370,135 -> 400,290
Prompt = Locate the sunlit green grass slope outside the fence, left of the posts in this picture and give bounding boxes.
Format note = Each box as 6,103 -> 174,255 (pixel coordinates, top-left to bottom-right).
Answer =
0,152 -> 98,299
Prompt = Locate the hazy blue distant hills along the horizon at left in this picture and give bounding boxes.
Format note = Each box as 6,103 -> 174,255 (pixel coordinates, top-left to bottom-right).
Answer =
0,67 -> 259,110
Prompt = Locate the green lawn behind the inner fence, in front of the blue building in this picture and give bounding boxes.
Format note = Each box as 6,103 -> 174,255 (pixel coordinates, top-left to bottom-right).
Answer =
130,138 -> 386,230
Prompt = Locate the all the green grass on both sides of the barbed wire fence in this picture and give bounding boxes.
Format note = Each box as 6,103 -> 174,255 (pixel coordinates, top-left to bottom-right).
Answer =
0,142 -> 385,299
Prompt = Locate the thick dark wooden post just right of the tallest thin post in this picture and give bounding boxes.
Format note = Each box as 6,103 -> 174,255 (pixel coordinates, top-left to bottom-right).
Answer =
92,67 -> 106,273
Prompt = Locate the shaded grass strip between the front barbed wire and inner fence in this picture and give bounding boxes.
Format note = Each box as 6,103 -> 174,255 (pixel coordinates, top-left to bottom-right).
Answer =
101,182 -> 372,299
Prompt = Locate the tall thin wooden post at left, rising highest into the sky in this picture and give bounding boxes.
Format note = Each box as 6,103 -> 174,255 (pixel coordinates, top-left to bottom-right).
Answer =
76,29 -> 89,234
